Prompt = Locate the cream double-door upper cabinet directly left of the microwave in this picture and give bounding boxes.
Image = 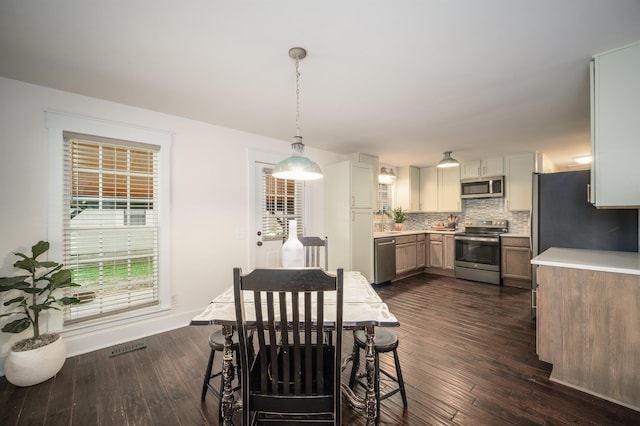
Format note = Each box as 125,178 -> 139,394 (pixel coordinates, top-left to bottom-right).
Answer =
420,167 -> 461,212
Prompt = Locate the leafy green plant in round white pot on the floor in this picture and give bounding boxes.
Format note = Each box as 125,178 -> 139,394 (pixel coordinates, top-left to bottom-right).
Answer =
0,241 -> 80,386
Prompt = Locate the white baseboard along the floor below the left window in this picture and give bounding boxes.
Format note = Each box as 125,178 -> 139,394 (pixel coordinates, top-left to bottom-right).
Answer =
0,310 -> 201,376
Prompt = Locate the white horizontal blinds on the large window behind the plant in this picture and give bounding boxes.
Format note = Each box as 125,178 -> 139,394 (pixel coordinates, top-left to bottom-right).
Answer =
63,132 -> 159,324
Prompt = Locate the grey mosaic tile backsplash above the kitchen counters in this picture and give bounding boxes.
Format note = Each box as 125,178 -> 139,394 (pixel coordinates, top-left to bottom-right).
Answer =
374,198 -> 531,235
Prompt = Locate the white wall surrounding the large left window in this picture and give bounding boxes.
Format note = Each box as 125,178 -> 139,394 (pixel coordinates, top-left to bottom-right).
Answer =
0,78 -> 342,372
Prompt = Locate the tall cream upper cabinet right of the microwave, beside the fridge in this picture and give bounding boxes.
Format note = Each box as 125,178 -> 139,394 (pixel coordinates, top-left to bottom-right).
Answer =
504,152 -> 535,211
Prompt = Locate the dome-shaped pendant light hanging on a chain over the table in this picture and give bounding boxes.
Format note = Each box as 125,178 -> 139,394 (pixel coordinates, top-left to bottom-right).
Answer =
272,47 -> 322,180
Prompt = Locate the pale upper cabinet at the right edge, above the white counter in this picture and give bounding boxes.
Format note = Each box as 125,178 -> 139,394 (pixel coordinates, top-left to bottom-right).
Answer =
591,43 -> 640,208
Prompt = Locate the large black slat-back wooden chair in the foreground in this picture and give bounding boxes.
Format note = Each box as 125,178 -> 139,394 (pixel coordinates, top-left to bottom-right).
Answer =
233,268 -> 343,425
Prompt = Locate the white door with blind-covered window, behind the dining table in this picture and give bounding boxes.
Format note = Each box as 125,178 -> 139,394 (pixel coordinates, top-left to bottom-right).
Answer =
249,161 -> 304,268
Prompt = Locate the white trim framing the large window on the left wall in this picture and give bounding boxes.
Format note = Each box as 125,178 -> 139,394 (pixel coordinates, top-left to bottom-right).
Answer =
45,110 -> 172,331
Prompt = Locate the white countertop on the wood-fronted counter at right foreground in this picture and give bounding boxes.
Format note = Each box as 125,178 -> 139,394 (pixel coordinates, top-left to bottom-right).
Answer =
531,247 -> 640,275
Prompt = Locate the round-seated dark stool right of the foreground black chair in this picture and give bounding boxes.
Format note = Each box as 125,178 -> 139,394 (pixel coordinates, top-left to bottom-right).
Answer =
349,327 -> 407,419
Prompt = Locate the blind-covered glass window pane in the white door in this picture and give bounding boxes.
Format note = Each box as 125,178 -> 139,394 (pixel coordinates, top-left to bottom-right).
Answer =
262,167 -> 304,241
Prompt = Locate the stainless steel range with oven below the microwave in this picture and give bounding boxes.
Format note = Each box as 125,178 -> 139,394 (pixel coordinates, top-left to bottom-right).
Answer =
455,220 -> 508,284
